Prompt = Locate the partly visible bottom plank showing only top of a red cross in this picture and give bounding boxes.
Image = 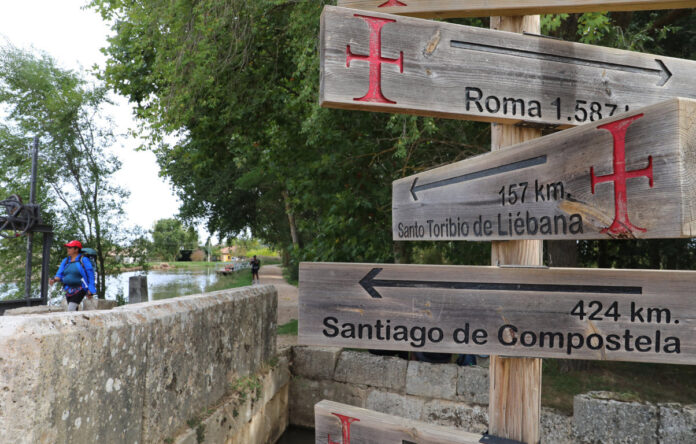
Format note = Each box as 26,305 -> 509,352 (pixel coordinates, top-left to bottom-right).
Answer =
314,400 -> 484,444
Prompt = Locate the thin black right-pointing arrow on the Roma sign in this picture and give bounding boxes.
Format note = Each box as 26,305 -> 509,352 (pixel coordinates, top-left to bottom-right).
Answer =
450,40 -> 672,86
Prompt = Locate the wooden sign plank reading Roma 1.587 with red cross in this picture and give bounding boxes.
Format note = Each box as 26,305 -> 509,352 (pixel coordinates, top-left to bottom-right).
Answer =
320,6 -> 696,127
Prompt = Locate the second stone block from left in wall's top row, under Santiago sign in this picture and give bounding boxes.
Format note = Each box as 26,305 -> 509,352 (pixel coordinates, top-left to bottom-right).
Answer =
334,350 -> 408,391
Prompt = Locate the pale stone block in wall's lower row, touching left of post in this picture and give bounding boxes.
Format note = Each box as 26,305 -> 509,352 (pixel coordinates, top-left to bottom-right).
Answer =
421,399 -> 488,433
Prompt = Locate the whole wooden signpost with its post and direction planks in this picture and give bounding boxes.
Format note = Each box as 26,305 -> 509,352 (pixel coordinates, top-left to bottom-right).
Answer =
310,0 -> 696,444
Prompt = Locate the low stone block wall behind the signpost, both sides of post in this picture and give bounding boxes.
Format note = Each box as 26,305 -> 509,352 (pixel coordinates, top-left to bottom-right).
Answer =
290,346 -> 696,444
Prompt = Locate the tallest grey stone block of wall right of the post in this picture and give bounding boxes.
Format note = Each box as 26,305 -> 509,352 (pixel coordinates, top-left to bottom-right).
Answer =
573,392 -> 659,444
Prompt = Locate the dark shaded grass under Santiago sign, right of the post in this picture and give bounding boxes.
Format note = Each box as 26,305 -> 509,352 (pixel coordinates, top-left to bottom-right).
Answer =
541,359 -> 696,414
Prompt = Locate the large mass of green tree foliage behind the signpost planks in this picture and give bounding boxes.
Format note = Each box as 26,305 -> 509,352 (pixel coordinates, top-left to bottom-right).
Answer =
91,0 -> 696,274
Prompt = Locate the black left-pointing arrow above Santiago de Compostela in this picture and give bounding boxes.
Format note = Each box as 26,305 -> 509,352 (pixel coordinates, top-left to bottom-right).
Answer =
360,268 -> 643,299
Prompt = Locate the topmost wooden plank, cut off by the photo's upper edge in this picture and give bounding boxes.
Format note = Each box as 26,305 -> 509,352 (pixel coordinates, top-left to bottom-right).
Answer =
338,0 -> 696,18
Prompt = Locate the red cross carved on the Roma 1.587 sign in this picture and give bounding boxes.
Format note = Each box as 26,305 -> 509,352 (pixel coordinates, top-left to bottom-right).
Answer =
346,14 -> 404,103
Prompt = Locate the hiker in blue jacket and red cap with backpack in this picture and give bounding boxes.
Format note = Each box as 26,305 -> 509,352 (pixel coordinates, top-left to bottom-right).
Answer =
48,240 -> 97,311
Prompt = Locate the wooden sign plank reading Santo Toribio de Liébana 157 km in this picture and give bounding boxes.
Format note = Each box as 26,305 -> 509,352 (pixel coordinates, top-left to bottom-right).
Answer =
392,99 -> 696,241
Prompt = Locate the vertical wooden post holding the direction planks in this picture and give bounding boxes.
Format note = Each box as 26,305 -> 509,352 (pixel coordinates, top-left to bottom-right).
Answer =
488,15 -> 543,444
